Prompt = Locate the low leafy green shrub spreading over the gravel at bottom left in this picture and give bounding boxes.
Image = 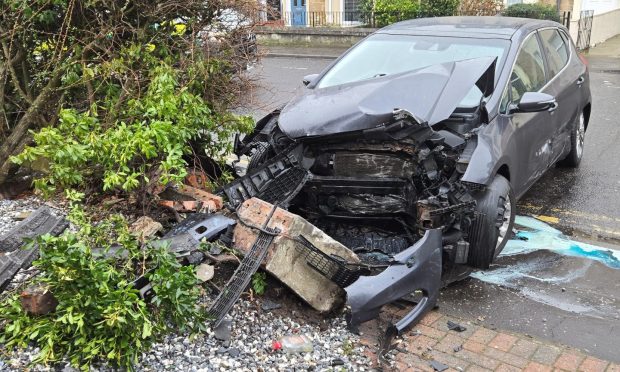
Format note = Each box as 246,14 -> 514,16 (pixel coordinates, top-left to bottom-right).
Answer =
0,192 -> 207,370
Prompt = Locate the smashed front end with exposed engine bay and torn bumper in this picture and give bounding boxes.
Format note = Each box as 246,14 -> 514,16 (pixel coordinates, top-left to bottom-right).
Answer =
217,110 -> 494,338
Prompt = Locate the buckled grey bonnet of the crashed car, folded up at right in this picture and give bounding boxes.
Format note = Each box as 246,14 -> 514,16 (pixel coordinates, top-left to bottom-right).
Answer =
279,57 -> 496,138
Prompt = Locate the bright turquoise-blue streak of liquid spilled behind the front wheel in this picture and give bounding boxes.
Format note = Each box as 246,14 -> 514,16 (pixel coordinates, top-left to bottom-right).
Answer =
501,216 -> 620,269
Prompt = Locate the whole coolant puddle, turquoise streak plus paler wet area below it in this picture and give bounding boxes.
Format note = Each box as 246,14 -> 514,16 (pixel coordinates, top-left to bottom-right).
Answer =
471,216 -> 620,318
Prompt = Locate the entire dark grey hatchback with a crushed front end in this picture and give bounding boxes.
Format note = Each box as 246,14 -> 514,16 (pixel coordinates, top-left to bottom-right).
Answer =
221,17 -> 591,332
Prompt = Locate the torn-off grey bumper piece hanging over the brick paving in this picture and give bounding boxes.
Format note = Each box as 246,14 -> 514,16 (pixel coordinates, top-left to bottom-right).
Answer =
345,229 -> 442,334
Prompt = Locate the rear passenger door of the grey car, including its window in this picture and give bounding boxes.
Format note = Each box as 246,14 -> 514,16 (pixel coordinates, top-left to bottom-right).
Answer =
538,27 -> 582,163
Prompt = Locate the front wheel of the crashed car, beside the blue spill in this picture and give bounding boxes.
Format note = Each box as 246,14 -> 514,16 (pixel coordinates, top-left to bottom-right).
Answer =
468,174 -> 516,269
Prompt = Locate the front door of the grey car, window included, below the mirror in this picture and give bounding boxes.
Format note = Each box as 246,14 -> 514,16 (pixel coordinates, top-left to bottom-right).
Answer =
502,32 -> 555,195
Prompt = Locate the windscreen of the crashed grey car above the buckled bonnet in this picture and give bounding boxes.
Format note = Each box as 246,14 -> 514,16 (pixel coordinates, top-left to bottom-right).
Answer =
316,34 -> 510,107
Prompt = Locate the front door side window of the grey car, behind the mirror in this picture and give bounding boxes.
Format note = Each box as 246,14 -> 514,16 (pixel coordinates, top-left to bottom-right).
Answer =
509,34 -> 546,103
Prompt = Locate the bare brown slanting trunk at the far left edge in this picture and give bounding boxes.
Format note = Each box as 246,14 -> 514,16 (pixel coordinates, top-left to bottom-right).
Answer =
0,71 -> 61,184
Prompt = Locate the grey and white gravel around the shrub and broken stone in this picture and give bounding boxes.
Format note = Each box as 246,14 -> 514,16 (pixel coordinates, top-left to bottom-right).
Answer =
0,197 -> 370,372
